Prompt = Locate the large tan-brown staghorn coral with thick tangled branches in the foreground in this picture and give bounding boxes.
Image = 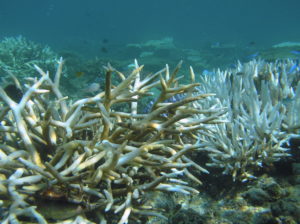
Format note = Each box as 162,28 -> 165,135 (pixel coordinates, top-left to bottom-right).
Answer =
0,59 -> 220,223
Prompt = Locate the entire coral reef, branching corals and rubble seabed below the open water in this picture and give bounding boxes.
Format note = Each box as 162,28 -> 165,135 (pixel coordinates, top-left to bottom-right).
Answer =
0,37 -> 300,224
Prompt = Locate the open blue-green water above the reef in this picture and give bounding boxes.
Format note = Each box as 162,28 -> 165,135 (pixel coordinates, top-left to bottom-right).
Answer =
0,0 -> 300,55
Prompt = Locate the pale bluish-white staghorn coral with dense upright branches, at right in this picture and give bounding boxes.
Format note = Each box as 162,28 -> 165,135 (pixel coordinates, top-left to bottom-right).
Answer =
194,60 -> 300,181
